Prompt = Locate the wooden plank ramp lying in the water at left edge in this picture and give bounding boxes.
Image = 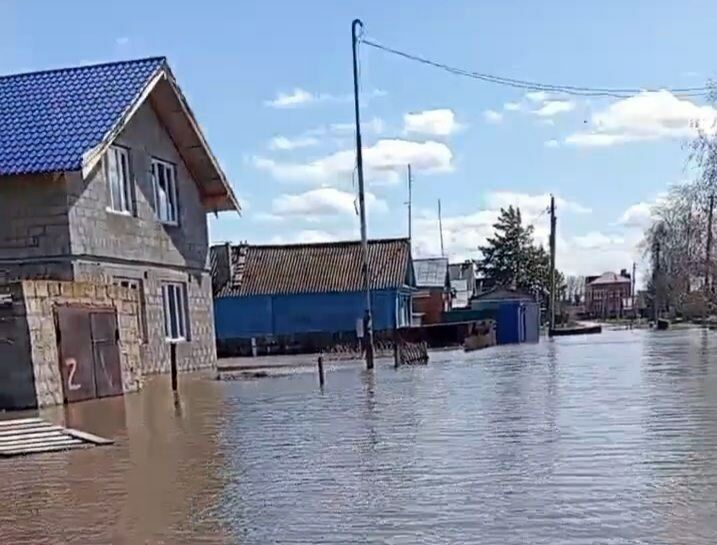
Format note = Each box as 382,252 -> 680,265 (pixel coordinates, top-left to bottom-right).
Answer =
0,418 -> 112,457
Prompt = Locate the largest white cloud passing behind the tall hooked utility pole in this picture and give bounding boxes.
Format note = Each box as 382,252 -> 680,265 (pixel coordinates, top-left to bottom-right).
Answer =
253,139 -> 453,184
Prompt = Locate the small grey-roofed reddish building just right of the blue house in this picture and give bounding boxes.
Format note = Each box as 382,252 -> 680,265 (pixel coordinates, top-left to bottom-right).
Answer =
413,257 -> 451,324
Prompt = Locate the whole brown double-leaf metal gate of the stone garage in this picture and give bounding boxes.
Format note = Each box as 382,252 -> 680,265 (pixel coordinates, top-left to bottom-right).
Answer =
57,307 -> 122,403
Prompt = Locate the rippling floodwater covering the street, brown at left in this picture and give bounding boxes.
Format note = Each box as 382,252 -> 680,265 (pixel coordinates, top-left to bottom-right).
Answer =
0,330 -> 717,545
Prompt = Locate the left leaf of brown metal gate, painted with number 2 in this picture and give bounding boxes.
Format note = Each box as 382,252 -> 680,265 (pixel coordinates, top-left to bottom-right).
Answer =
57,307 -> 97,403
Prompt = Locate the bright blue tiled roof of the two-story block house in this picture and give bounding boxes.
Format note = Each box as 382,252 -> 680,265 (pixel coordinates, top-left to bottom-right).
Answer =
0,57 -> 166,176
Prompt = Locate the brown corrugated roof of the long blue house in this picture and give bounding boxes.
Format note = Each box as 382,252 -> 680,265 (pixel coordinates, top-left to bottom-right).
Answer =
211,239 -> 411,297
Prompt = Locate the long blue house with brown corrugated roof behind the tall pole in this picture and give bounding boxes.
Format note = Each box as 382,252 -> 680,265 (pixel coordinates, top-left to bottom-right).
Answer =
211,239 -> 415,341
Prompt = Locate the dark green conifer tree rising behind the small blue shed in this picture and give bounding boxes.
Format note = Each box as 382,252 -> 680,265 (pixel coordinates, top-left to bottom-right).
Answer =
478,206 -> 563,293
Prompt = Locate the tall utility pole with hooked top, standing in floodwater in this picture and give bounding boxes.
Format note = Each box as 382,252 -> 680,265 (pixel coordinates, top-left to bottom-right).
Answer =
351,19 -> 373,369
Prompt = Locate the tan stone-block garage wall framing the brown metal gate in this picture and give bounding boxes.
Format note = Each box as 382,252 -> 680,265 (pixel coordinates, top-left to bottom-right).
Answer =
0,280 -> 142,408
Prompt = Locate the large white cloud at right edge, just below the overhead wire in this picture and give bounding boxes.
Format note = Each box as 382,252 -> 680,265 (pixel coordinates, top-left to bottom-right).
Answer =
565,90 -> 717,147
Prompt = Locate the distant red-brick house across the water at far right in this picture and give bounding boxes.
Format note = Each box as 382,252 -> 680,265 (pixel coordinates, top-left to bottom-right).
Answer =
585,270 -> 632,318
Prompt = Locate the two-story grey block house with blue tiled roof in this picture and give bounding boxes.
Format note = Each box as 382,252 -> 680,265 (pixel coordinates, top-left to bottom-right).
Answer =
0,58 -> 239,373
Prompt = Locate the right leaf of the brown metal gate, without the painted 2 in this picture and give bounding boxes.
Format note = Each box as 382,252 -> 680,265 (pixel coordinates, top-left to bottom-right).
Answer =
90,311 -> 122,397
